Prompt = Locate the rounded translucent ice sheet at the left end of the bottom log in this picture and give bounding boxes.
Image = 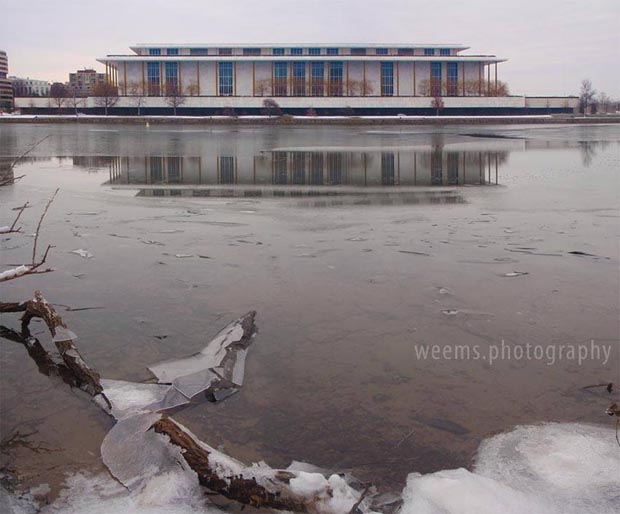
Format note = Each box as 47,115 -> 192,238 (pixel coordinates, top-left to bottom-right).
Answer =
101,413 -> 185,491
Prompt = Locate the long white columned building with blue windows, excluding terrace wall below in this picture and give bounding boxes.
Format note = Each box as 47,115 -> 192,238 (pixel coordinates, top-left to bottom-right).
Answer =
98,44 -> 505,101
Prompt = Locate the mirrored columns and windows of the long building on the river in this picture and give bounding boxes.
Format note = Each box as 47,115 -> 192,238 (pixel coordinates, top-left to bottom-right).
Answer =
109,145 -> 508,194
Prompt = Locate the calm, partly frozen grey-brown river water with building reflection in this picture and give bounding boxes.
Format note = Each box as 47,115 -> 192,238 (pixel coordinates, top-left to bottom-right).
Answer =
0,124 -> 620,489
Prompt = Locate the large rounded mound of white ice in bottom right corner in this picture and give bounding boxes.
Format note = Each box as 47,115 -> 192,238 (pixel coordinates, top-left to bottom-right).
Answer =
402,423 -> 620,514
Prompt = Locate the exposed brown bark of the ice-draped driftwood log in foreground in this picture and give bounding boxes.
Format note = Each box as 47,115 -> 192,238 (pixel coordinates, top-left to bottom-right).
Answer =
0,291 -> 361,513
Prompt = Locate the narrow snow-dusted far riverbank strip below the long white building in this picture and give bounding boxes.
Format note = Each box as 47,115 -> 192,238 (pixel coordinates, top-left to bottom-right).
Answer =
0,114 -> 620,126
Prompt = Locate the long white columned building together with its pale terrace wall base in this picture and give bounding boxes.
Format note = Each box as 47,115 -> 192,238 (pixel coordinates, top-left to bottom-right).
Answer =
12,44 -> 572,114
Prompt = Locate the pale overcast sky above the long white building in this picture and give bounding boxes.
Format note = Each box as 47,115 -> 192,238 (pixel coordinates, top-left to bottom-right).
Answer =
0,0 -> 620,98
